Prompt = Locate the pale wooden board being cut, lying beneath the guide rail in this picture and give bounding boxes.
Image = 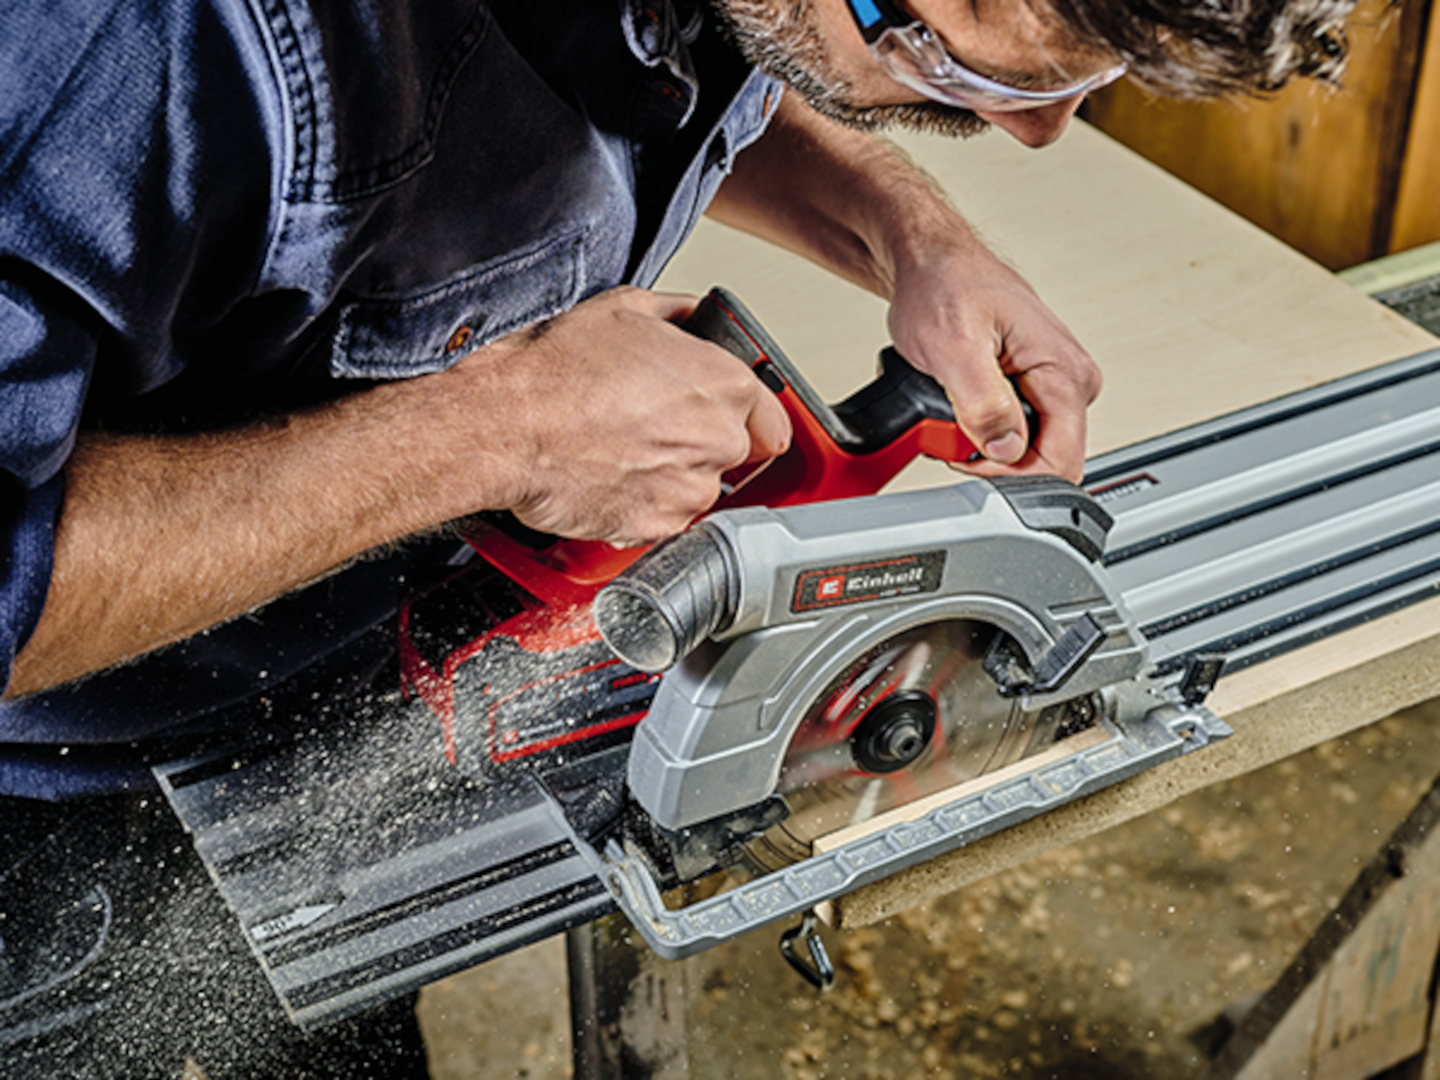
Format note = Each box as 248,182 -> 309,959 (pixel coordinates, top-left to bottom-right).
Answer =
662,116 -> 1440,926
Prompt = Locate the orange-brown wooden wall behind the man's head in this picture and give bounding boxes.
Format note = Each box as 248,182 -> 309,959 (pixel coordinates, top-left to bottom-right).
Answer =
1083,0 -> 1440,269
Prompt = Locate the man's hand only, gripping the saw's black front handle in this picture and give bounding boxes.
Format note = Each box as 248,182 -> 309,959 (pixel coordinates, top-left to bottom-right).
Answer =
890,235 -> 1100,482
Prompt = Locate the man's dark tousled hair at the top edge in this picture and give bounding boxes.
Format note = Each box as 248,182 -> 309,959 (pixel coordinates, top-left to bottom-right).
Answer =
1031,0 -> 1355,98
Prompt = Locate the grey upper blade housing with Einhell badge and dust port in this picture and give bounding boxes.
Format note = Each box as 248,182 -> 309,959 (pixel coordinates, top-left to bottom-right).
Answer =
596,477 -> 1148,829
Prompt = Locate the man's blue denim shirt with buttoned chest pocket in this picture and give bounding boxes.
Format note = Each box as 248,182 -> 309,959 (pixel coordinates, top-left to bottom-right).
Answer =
0,0 -> 779,796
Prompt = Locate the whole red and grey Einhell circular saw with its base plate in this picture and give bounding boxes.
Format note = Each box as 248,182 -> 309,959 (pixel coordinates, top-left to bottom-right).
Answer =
402,289 -> 1228,958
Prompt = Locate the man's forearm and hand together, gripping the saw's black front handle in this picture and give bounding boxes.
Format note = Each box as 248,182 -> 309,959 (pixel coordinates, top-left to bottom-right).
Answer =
710,94 -> 1100,480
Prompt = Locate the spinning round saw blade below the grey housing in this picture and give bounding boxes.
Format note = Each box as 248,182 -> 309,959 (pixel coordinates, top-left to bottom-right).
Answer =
750,619 -> 1057,870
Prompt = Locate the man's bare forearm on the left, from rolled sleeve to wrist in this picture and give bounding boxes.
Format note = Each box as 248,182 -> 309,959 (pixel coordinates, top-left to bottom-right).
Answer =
7,371 -> 494,696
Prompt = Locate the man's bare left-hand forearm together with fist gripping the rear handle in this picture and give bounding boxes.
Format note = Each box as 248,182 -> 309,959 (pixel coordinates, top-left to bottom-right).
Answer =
6,288 -> 789,696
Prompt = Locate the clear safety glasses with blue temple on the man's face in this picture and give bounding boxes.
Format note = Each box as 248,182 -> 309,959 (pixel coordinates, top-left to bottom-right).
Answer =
847,0 -> 1125,112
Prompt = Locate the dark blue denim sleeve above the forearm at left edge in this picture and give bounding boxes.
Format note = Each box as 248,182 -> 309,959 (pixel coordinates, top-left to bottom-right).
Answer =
0,0 -> 279,694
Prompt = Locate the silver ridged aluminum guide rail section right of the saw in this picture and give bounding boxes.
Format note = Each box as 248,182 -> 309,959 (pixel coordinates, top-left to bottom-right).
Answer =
1086,350 -> 1440,671
